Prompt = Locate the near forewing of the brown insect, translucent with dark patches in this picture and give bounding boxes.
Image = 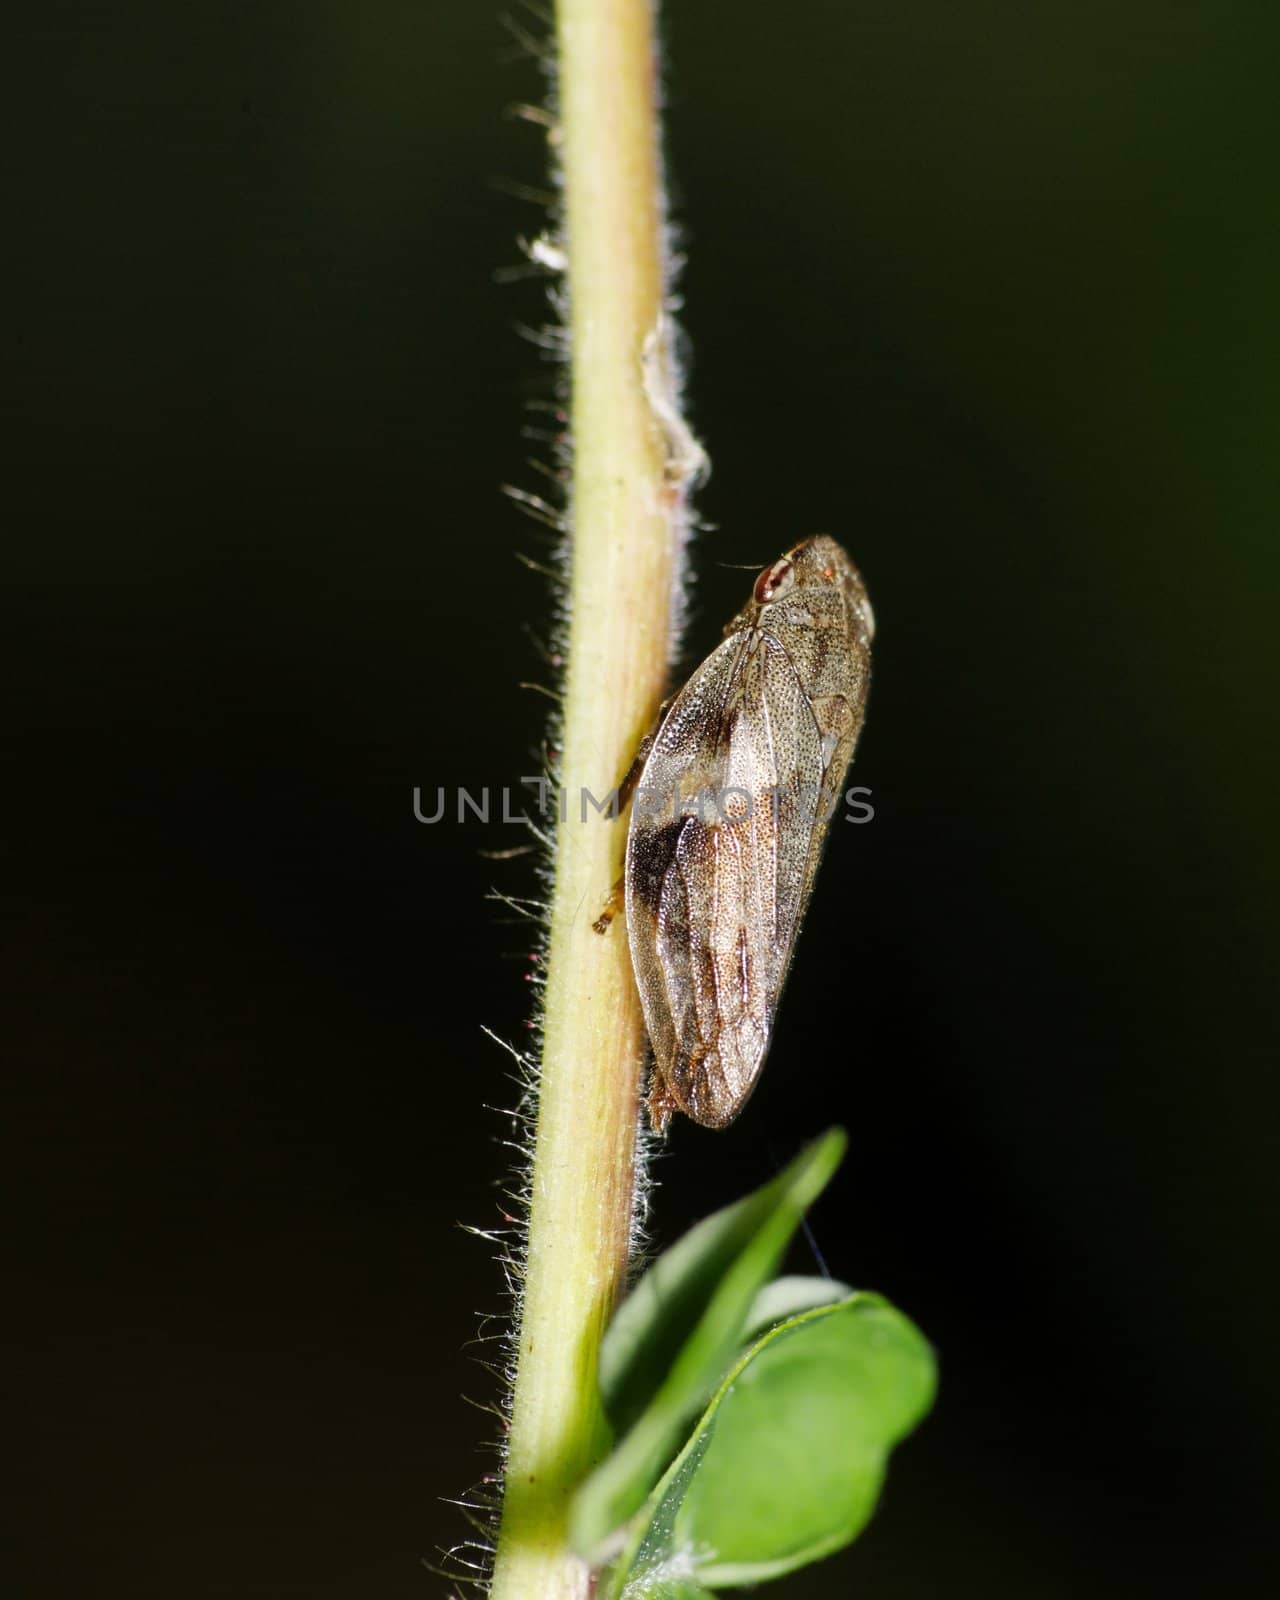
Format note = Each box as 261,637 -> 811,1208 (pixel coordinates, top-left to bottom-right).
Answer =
627,620 -> 822,1128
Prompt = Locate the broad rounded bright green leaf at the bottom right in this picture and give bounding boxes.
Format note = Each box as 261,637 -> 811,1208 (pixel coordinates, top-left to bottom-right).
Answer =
605,1294 -> 934,1600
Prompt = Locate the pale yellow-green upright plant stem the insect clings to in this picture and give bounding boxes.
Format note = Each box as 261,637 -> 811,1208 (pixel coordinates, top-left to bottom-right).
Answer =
491,0 -> 680,1600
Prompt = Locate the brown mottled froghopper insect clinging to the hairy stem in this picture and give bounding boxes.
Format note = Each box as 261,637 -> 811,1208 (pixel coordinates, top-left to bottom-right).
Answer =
624,534 -> 875,1131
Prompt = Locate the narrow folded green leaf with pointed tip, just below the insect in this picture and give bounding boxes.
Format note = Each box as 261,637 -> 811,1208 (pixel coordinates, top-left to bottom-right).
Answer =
570,1128 -> 846,1560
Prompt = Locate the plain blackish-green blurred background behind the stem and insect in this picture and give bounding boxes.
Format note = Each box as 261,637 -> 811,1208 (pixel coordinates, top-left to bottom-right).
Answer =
3,0 -> 1280,1600
